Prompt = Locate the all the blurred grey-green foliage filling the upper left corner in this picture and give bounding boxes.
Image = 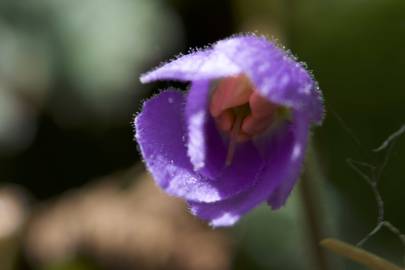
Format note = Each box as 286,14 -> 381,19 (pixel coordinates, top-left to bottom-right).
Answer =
0,0 -> 182,154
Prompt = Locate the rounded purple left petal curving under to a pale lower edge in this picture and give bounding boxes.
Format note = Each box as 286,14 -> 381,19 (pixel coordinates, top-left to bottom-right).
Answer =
135,90 -> 257,202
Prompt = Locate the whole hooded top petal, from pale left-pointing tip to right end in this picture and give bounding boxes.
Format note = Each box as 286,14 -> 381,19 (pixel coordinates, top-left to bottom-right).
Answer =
141,34 -> 324,124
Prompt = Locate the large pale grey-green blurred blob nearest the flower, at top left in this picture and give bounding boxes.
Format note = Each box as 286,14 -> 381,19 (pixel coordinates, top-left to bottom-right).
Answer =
41,0 -> 181,121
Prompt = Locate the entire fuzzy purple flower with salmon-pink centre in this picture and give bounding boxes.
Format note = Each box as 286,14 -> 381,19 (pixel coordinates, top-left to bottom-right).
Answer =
135,34 -> 324,226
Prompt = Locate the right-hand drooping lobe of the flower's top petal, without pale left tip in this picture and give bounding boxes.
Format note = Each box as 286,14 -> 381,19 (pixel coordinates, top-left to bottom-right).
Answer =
213,35 -> 324,123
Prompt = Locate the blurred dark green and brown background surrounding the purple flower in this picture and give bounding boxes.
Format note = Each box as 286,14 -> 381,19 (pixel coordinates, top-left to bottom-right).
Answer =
0,0 -> 405,270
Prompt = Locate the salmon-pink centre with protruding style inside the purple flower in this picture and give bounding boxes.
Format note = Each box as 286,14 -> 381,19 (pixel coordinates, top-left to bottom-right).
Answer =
209,75 -> 278,166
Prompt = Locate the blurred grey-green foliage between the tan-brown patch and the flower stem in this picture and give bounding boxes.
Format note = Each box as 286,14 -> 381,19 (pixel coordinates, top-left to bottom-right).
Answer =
235,193 -> 310,270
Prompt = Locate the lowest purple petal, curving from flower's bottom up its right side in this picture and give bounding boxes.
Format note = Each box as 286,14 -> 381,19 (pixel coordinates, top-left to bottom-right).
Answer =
189,110 -> 309,227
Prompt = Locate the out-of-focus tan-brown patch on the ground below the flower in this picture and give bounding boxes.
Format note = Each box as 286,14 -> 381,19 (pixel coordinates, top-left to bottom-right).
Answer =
26,170 -> 231,270
